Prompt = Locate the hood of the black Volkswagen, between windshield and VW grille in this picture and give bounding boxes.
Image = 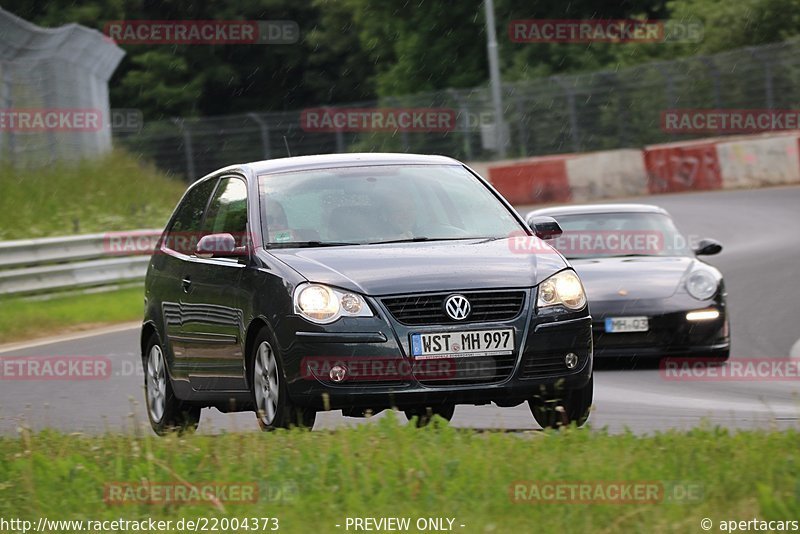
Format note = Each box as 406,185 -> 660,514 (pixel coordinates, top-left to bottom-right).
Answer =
270,238 -> 567,296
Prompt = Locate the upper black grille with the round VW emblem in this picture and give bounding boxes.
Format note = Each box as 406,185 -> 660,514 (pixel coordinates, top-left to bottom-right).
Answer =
381,291 -> 525,325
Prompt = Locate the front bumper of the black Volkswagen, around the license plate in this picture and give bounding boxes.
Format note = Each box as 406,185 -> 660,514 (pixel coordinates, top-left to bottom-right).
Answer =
278,290 -> 593,411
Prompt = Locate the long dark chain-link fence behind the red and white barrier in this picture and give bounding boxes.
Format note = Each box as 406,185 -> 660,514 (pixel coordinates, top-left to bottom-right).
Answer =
111,40 -> 800,181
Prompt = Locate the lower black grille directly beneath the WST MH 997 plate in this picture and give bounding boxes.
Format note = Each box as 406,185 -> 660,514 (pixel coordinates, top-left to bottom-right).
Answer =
414,354 -> 517,386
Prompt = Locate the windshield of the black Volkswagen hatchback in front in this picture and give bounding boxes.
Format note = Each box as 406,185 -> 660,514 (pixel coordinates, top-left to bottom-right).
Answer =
259,165 -> 522,247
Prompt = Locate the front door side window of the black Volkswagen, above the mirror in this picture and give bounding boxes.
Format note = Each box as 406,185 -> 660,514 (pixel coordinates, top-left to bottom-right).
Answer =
203,178 -> 247,247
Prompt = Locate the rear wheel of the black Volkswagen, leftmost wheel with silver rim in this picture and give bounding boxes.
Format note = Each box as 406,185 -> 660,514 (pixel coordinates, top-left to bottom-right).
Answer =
143,334 -> 200,436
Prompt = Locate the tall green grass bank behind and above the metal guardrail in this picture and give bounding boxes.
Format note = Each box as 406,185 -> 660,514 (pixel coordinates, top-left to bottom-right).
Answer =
0,152 -> 186,241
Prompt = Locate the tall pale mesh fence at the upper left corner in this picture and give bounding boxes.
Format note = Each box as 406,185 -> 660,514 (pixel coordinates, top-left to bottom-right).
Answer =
0,9 -> 125,167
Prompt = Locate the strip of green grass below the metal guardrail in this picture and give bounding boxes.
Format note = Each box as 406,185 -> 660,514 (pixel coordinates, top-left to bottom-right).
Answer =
0,287 -> 144,343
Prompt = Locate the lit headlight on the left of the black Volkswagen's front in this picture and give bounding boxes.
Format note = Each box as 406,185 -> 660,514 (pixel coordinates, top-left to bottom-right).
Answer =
294,284 -> 372,324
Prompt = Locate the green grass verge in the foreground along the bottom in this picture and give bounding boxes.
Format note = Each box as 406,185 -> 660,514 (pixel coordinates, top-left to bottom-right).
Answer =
0,417 -> 800,533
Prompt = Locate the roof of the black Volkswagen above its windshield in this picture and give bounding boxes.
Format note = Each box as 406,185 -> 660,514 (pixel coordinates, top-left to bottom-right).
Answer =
237,152 -> 463,175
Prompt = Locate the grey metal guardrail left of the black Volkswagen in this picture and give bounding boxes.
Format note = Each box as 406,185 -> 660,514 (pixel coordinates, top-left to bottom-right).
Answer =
0,230 -> 160,295
